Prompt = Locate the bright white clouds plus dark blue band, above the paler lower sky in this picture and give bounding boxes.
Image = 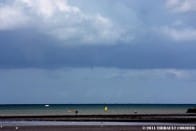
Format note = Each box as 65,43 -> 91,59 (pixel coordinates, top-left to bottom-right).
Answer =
0,0 -> 196,69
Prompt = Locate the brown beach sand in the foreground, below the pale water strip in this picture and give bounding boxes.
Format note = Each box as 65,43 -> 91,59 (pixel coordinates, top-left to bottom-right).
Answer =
0,122 -> 196,131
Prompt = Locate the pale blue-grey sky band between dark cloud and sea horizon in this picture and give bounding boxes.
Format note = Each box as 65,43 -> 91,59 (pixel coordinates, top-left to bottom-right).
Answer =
0,68 -> 196,104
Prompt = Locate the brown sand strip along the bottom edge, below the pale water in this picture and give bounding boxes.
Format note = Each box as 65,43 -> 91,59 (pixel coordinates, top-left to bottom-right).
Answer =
0,125 -> 196,131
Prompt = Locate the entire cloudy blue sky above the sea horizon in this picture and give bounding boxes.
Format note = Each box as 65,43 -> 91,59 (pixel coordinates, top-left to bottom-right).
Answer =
0,0 -> 196,104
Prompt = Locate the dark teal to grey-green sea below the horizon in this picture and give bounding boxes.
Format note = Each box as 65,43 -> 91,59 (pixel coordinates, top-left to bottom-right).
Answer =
0,104 -> 196,116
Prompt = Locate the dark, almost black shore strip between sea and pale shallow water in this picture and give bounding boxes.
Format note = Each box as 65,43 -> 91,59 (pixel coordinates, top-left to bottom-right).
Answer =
0,113 -> 196,123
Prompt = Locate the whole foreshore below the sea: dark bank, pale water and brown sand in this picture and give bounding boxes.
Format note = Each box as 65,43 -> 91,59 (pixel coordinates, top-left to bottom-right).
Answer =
0,114 -> 196,131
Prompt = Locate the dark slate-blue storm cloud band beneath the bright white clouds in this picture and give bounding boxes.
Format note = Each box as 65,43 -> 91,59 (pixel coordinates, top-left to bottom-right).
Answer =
0,30 -> 196,69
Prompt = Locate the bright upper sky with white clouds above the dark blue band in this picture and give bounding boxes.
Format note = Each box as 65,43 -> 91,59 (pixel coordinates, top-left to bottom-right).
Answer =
0,0 -> 196,45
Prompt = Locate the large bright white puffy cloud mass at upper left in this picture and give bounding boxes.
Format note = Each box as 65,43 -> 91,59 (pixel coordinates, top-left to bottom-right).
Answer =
0,0 -> 130,44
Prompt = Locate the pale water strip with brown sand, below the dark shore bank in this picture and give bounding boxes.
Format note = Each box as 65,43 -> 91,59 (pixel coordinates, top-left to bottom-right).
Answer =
0,121 -> 196,131
